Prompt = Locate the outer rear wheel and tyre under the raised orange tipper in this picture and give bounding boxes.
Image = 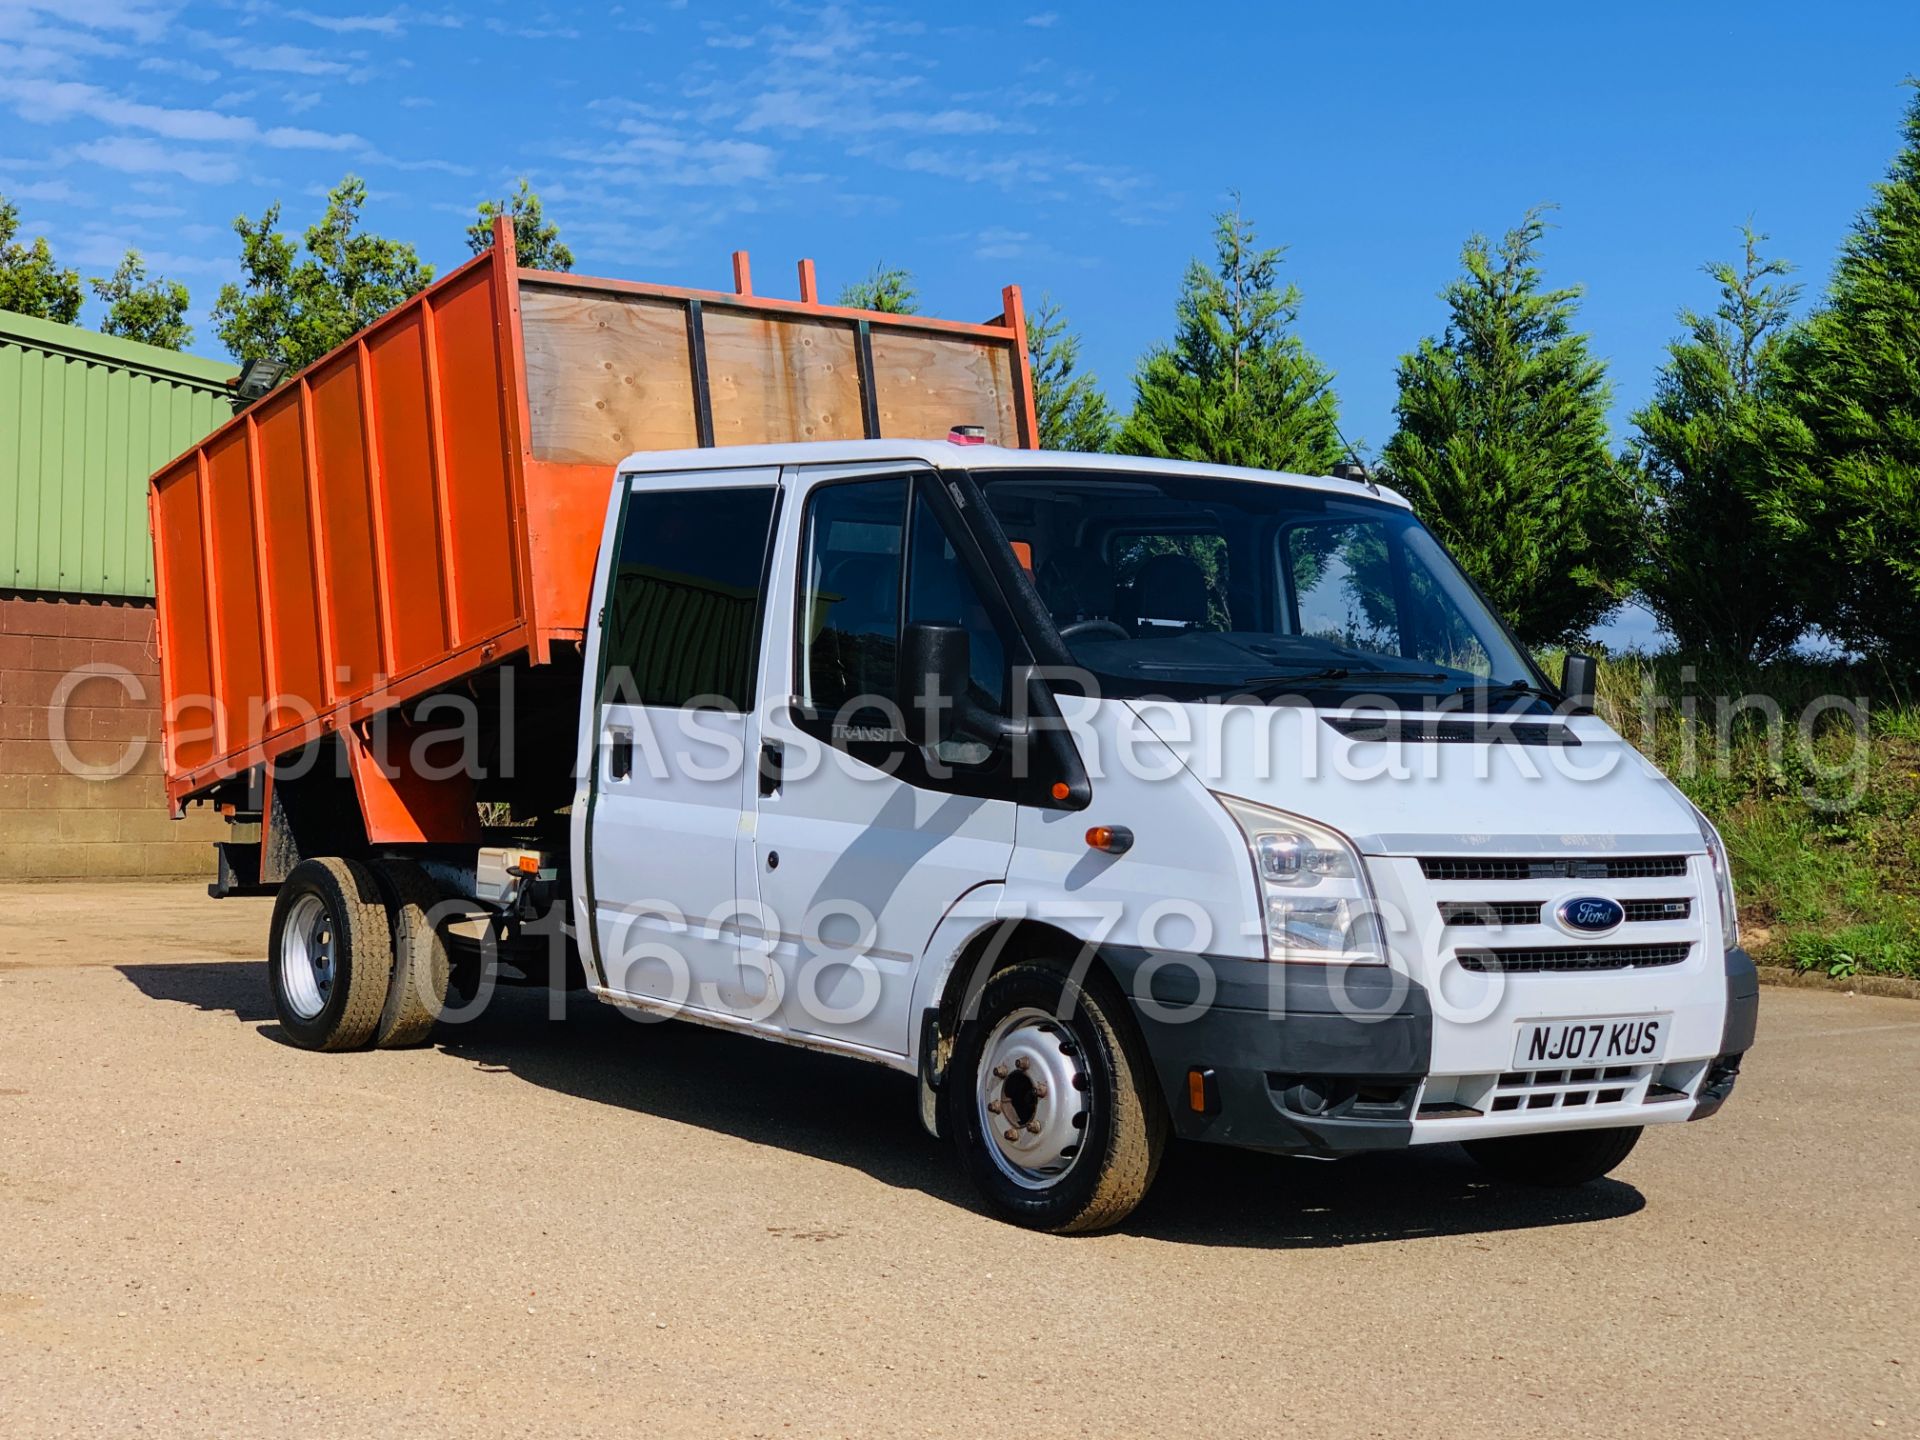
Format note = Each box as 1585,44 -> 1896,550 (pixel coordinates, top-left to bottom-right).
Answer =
267,856 -> 394,1050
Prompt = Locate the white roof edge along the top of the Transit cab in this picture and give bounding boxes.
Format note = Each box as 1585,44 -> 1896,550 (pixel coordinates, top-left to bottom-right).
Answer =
618,440 -> 1413,509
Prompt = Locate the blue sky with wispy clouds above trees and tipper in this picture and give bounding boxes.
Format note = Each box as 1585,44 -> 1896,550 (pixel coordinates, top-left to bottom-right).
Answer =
0,0 -> 1920,458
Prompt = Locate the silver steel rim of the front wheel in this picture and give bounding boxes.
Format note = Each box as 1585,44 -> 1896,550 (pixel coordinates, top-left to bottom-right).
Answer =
973,1006 -> 1092,1190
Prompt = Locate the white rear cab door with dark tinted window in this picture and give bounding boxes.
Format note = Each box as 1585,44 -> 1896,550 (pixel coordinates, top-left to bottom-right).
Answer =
586,468 -> 780,1016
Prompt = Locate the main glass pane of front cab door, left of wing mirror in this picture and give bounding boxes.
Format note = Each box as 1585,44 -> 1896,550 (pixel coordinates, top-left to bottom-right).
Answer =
799,480 -> 906,728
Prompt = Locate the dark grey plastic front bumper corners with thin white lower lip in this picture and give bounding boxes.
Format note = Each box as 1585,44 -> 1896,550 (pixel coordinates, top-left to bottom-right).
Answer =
1108,948 -> 1759,1156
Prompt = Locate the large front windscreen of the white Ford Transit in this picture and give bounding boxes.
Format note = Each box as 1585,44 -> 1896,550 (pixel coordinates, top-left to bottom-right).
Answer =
975,470 -> 1540,703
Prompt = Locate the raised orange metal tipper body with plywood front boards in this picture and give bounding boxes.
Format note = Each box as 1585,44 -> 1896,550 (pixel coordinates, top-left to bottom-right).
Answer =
148,221 -> 1037,808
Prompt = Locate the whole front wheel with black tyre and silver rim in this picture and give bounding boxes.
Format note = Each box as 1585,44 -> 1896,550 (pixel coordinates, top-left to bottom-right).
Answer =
943,964 -> 1167,1235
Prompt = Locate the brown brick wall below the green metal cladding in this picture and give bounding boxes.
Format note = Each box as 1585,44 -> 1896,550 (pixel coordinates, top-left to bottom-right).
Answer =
0,589 -> 227,879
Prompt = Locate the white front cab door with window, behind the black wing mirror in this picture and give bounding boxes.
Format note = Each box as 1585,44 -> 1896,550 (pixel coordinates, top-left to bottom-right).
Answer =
747,467 -> 1021,1054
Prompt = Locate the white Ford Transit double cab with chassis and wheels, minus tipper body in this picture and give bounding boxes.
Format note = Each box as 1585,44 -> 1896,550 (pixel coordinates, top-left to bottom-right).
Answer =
156,242 -> 1757,1231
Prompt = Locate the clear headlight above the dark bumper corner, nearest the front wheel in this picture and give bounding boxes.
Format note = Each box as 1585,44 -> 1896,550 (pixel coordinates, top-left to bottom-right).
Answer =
1215,795 -> 1386,966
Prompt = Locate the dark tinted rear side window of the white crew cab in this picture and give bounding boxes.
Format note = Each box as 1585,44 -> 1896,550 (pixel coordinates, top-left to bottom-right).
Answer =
605,486 -> 774,710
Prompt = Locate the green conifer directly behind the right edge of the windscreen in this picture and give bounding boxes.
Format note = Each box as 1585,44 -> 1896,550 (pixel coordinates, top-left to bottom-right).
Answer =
1382,207 -> 1632,645
